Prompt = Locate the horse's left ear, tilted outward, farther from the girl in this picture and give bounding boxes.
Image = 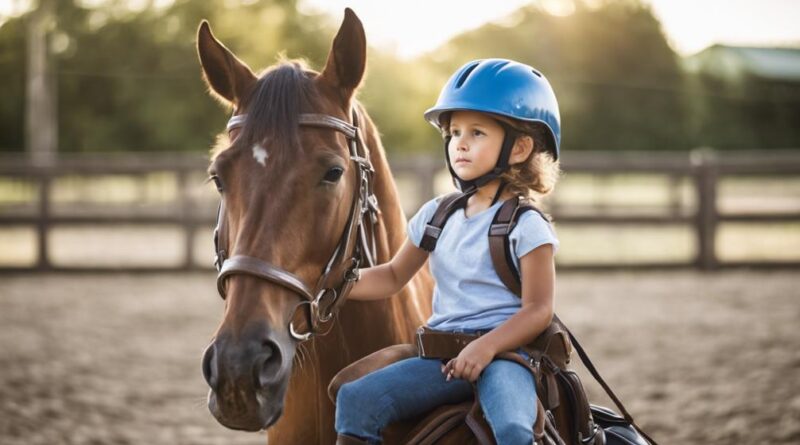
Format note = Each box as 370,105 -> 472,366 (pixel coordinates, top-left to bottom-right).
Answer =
197,20 -> 256,106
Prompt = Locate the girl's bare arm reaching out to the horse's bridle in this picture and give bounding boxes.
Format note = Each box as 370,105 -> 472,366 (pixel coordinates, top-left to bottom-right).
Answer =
348,239 -> 428,300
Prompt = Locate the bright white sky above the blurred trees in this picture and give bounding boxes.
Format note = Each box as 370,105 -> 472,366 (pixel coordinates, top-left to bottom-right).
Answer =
300,0 -> 800,58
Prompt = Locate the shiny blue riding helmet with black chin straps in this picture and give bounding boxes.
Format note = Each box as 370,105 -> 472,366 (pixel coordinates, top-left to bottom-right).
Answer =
425,59 -> 561,193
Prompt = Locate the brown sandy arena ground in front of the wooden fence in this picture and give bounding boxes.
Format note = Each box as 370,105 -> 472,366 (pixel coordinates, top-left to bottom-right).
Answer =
0,271 -> 800,445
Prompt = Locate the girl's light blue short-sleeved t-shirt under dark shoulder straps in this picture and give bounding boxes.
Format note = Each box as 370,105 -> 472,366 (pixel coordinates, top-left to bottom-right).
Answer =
408,198 -> 558,331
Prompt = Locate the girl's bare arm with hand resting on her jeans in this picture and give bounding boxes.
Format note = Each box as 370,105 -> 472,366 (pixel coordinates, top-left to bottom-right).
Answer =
442,244 -> 556,382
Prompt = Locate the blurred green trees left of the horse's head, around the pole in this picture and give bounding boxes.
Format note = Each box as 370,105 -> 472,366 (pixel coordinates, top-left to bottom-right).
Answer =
0,0 -> 333,152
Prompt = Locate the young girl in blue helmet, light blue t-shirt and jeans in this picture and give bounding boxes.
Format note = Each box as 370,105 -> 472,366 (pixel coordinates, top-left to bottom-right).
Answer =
336,59 -> 560,445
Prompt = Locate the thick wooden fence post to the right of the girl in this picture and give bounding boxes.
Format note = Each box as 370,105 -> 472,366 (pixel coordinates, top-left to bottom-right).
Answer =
690,147 -> 719,270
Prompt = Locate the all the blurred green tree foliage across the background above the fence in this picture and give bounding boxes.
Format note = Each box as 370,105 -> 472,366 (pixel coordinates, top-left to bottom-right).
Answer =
0,0 -> 800,152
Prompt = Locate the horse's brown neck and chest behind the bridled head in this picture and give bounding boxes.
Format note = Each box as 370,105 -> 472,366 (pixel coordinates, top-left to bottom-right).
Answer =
269,113 -> 432,444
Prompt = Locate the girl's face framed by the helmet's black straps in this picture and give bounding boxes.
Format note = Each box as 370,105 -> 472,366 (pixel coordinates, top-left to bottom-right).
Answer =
447,111 -> 505,181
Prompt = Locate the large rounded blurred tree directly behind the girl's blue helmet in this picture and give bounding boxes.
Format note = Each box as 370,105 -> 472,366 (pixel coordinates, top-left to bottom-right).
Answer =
365,1 -> 690,150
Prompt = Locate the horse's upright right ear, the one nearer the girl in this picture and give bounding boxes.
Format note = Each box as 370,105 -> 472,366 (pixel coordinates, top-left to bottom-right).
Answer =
320,8 -> 367,100
